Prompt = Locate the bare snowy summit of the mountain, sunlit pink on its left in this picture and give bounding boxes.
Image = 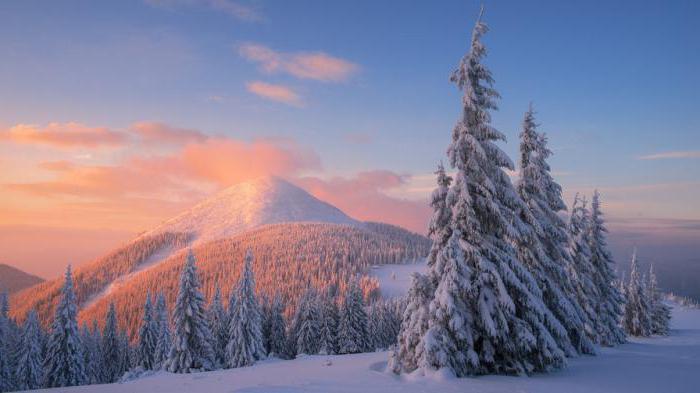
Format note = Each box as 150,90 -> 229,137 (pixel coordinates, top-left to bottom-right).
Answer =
142,177 -> 361,244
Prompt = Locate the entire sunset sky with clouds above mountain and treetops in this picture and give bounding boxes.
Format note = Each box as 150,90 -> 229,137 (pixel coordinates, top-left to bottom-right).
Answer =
0,0 -> 700,277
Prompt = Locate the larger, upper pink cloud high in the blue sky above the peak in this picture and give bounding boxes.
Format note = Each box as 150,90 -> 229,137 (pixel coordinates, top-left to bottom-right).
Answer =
238,43 -> 360,82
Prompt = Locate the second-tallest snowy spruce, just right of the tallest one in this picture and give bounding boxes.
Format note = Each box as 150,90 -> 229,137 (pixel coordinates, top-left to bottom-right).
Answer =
518,105 -> 595,356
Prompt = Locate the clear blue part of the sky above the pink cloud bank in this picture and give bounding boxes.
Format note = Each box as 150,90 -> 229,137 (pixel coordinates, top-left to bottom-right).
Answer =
0,0 -> 700,276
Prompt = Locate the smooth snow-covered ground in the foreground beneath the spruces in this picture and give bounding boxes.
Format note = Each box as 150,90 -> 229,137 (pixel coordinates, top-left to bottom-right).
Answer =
38,306 -> 700,393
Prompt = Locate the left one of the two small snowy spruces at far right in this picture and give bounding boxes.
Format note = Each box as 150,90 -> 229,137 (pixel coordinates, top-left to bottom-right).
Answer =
622,250 -> 651,337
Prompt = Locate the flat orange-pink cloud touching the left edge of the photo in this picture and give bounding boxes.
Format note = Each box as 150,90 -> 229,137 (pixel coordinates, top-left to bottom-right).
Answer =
0,122 -> 128,149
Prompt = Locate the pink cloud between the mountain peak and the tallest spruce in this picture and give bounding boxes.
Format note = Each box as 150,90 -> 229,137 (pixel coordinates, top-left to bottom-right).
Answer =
296,170 -> 430,233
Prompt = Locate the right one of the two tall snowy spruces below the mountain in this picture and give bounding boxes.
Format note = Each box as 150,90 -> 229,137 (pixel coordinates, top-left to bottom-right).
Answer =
226,250 -> 265,368
